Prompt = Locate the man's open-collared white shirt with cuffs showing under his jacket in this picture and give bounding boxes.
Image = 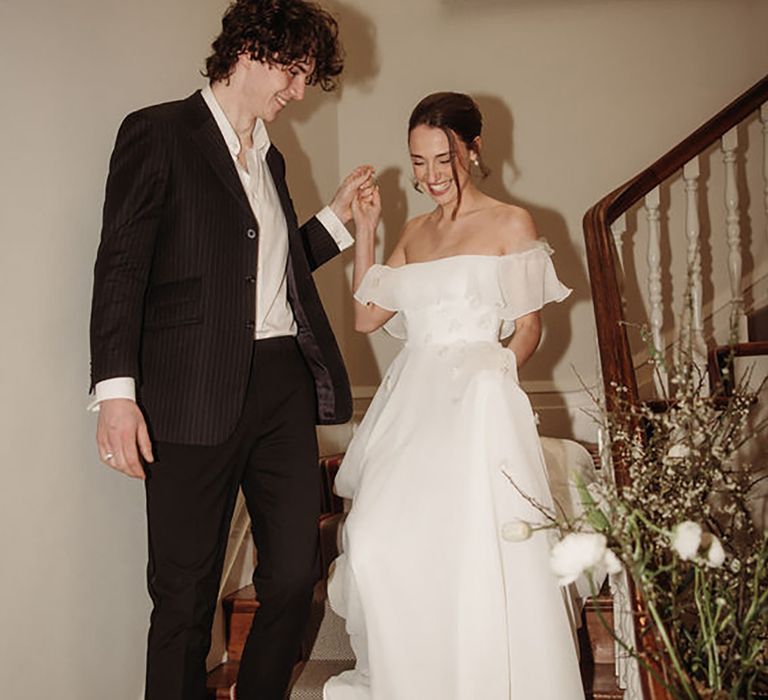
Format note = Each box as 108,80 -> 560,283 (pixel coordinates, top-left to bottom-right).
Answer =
88,85 -> 354,410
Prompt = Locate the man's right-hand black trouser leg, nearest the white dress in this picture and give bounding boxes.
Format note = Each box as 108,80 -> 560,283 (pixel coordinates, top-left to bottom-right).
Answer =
232,343 -> 321,700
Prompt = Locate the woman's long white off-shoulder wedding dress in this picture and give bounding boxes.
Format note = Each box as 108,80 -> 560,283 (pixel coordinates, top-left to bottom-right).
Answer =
324,241 -> 584,700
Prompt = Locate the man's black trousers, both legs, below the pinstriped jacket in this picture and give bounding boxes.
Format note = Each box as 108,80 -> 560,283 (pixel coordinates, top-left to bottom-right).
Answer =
146,338 -> 321,700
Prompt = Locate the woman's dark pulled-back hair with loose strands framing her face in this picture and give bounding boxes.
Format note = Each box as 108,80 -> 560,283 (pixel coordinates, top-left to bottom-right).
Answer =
408,92 -> 489,219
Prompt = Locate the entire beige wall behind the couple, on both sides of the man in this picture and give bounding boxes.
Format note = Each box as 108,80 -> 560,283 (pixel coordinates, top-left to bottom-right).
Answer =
0,0 -> 768,700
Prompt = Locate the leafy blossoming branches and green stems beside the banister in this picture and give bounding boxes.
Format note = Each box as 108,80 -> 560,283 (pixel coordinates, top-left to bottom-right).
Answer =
584,334 -> 768,700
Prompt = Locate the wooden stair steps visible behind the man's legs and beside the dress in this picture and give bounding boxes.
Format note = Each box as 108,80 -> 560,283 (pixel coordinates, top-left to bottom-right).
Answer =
208,455 -> 624,700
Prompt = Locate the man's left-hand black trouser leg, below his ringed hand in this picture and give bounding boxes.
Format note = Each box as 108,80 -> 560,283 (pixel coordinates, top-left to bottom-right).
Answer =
141,443 -> 243,700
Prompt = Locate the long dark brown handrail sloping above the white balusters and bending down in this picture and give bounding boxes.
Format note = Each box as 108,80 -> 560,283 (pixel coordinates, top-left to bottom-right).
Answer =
583,76 -> 768,700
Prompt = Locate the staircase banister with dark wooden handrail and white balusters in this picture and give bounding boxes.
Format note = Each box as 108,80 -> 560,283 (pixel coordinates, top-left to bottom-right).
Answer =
584,76 -> 768,700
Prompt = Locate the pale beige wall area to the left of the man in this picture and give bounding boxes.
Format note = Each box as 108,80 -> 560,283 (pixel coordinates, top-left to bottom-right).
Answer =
0,0 -> 216,700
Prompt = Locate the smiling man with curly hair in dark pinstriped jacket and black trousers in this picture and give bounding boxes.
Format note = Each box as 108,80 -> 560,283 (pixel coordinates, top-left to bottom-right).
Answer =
91,0 -> 373,700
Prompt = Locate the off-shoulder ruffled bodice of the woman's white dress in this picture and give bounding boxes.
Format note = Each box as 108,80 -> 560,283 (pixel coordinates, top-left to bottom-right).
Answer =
355,241 -> 571,345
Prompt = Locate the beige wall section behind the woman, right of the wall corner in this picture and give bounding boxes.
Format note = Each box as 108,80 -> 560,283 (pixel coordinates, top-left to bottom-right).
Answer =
332,0 -> 768,437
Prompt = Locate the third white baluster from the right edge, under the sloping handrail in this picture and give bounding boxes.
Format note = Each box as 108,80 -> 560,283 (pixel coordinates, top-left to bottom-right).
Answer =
683,156 -> 707,372
